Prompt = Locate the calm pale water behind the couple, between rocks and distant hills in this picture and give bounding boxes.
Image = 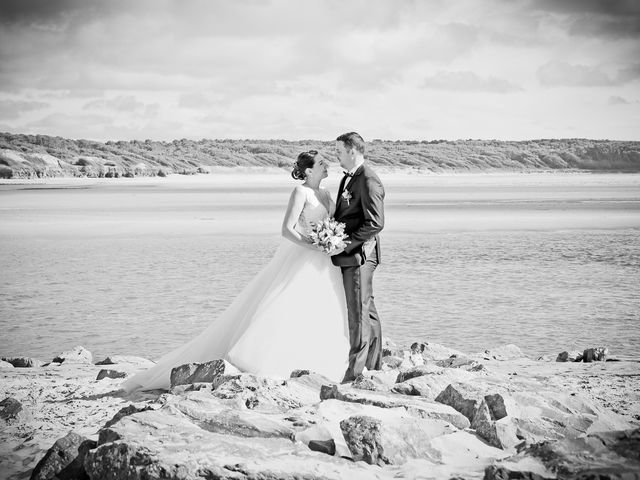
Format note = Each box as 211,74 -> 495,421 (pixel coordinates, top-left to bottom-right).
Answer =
0,172 -> 640,360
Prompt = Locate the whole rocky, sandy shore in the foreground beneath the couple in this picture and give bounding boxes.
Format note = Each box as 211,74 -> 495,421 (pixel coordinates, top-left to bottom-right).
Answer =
0,342 -> 640,480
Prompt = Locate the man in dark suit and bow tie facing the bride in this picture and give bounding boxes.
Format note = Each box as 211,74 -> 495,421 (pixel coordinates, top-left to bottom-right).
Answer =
331,132 -> 384,383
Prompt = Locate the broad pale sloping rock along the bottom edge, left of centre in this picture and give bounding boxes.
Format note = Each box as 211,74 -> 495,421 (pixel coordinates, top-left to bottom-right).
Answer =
85,406 -> 378,480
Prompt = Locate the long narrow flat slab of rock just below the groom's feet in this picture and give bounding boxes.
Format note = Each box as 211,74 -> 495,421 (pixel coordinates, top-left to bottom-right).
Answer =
320,385 -> 470,429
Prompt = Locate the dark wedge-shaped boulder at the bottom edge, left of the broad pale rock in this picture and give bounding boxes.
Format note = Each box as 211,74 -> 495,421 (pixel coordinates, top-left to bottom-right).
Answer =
31,432 -> 96,480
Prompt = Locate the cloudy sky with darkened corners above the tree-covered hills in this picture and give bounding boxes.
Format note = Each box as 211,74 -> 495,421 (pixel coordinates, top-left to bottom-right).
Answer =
0,0 -> 640,140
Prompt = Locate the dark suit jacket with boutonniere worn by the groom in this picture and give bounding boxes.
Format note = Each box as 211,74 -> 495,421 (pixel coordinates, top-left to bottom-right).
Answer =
331,164 -> 384,267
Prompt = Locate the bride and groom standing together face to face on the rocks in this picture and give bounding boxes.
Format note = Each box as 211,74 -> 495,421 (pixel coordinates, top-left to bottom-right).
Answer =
122,132 -> 384,392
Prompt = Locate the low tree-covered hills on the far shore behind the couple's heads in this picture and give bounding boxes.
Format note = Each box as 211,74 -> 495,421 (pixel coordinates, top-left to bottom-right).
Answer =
0,133 -> 640,178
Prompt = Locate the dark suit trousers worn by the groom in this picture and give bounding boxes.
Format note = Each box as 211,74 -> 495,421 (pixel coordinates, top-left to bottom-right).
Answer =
341,244 -> 382,382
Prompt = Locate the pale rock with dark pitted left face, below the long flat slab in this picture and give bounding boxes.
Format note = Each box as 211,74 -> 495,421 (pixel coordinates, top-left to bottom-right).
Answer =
340,415 -> 457,466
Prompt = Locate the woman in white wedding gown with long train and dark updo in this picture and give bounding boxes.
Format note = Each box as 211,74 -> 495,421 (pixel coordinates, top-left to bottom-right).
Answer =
122,150 -> 349,392
